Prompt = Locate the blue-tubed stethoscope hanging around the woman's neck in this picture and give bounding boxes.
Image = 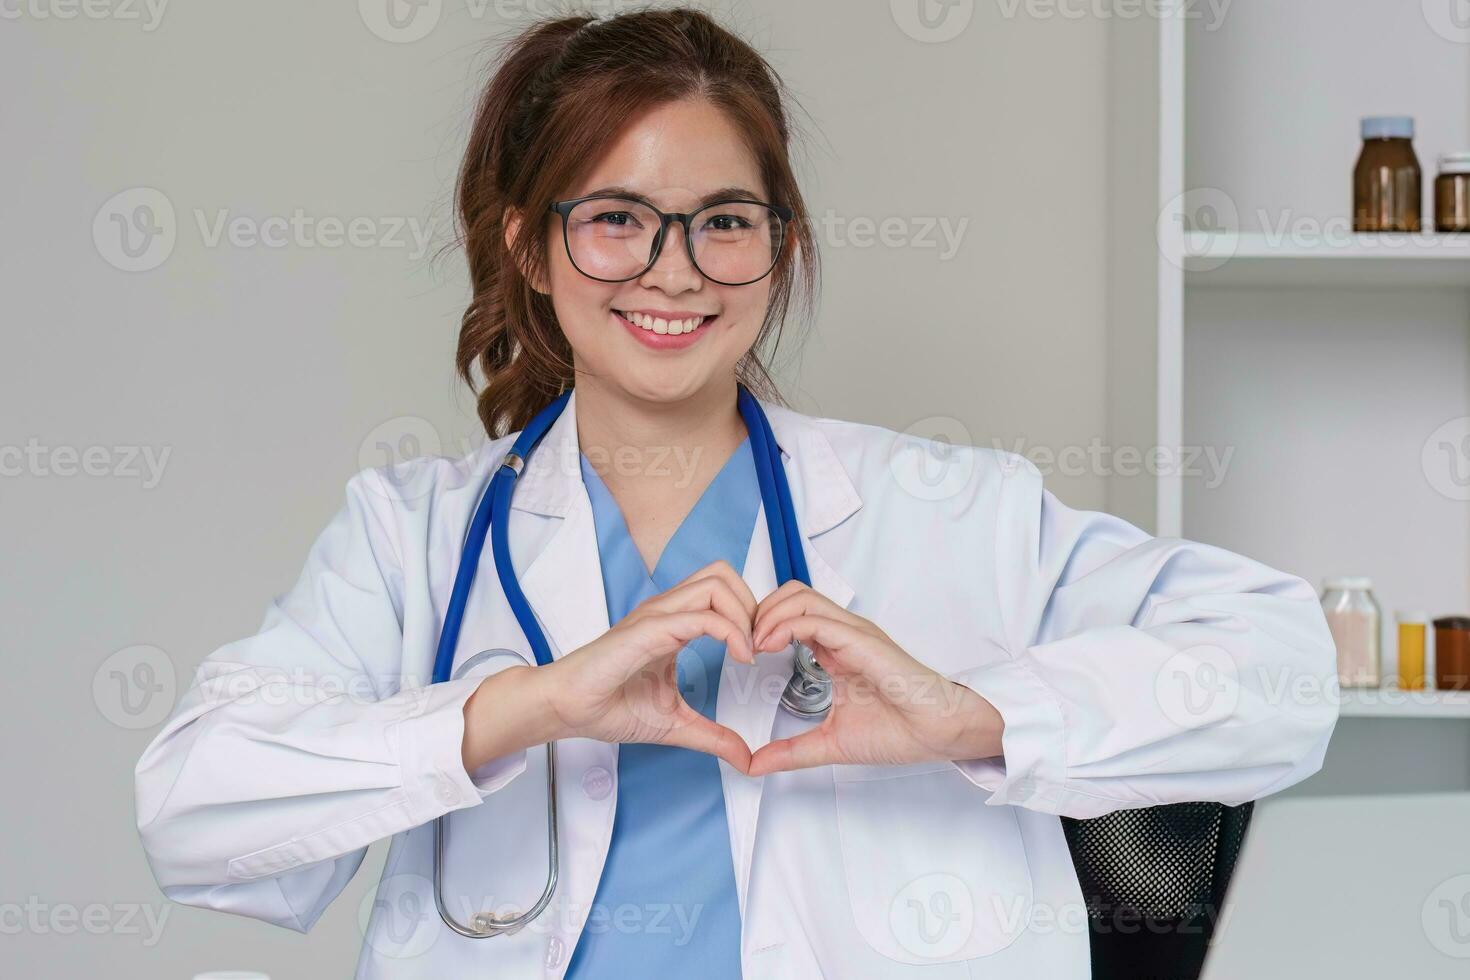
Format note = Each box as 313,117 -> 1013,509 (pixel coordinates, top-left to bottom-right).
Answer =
434,383 -> 832,939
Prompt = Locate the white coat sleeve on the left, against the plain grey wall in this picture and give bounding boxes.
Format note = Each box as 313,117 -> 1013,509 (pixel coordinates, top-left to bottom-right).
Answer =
135,470 -> 525,932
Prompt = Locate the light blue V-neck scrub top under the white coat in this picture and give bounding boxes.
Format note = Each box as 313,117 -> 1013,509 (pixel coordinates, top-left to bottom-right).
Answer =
567,436 -> 760,980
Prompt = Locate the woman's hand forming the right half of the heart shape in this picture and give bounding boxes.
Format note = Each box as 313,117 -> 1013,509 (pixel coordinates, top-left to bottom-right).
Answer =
748,580 -> 1004,776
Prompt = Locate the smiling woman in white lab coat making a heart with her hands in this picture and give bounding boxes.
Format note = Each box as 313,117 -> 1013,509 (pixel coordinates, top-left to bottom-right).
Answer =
137,10 -> 1335,980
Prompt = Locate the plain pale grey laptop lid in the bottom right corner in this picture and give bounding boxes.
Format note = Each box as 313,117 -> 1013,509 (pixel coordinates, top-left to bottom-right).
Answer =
1204,793 -> 1470,980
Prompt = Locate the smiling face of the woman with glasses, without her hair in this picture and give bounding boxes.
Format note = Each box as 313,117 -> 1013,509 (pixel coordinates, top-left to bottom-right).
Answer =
535,100 -> 772,403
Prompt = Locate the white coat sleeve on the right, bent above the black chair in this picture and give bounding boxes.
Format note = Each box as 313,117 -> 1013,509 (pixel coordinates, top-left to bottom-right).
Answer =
950,455 -> 1338,817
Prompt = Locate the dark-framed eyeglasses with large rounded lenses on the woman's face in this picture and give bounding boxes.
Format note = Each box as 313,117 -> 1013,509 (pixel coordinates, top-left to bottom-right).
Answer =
548,197 -> 795,287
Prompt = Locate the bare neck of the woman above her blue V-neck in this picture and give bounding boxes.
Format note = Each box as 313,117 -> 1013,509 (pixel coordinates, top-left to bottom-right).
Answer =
564,372 -> 747,500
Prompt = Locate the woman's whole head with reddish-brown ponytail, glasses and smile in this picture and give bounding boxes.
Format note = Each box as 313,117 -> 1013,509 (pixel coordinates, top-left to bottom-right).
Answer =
457,10 -> 817,433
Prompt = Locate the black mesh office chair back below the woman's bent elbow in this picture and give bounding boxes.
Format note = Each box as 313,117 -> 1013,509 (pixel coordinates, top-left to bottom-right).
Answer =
1061,802 -> 1254,980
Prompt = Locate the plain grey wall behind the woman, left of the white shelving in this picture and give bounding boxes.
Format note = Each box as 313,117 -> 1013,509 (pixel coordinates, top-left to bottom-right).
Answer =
0,0 -> 1105,980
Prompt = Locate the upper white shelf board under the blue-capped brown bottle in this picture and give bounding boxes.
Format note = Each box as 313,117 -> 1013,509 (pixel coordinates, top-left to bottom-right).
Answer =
1183,232 -> 1470,289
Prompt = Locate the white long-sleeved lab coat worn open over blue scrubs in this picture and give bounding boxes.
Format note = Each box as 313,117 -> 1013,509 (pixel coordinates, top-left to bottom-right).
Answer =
137,394 -> 1336,980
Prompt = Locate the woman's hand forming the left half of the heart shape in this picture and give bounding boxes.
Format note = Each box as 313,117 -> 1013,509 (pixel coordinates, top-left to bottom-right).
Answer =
465,561 -> 756,773
